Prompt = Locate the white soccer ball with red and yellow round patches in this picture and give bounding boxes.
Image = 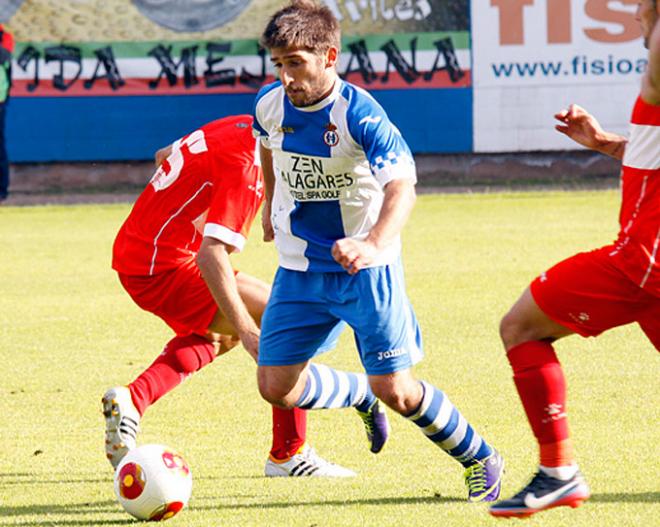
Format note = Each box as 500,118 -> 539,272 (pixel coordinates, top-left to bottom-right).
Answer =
115,445 -> 192,521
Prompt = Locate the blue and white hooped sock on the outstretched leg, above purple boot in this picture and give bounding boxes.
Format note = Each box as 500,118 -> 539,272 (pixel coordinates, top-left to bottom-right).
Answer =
406,381 -> 493,467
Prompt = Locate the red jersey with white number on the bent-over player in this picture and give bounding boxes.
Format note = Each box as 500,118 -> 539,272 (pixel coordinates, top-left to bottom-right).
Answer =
112,115 -> 263,276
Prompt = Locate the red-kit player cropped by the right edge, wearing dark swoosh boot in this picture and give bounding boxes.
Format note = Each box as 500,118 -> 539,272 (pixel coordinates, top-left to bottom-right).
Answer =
490,0 -> 660,516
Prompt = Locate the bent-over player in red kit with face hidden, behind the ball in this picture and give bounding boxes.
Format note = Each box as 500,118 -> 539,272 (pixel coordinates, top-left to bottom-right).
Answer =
103,116 -> 373,477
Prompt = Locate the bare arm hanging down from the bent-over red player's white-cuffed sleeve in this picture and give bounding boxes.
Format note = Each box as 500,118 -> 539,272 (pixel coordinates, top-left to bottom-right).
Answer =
197,236 -> 259,361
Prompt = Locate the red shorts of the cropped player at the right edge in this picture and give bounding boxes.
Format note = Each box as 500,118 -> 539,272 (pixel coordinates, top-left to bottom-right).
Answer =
530,246 -> 660,351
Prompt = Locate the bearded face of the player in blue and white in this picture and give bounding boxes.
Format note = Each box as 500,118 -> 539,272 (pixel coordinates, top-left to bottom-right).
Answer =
270,48 -> 337,106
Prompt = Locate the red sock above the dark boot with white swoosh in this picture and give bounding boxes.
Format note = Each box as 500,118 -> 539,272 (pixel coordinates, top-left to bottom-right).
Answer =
507,341 -> 573,467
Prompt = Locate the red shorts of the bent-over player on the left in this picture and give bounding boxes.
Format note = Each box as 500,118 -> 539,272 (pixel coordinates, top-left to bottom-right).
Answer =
119,258 -> 218,336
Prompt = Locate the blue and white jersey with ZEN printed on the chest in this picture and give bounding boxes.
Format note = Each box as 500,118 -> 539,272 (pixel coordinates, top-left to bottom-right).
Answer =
253,79 -> 416,272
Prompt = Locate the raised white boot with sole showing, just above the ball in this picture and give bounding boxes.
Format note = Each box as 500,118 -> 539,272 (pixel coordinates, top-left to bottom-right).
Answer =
101,386 -> 140,468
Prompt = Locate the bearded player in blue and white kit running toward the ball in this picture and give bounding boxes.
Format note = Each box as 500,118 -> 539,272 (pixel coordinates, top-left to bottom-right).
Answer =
253,0 -> 504,501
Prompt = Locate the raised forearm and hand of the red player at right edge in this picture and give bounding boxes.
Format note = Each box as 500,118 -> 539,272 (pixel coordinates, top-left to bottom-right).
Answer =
555,104 -> 628,160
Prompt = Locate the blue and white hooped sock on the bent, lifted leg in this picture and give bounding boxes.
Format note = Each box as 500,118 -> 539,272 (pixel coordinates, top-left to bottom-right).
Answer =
296,363 -> 376,412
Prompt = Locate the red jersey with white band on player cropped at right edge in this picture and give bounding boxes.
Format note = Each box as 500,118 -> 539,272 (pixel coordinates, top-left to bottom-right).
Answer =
611,96 -> 660,296
